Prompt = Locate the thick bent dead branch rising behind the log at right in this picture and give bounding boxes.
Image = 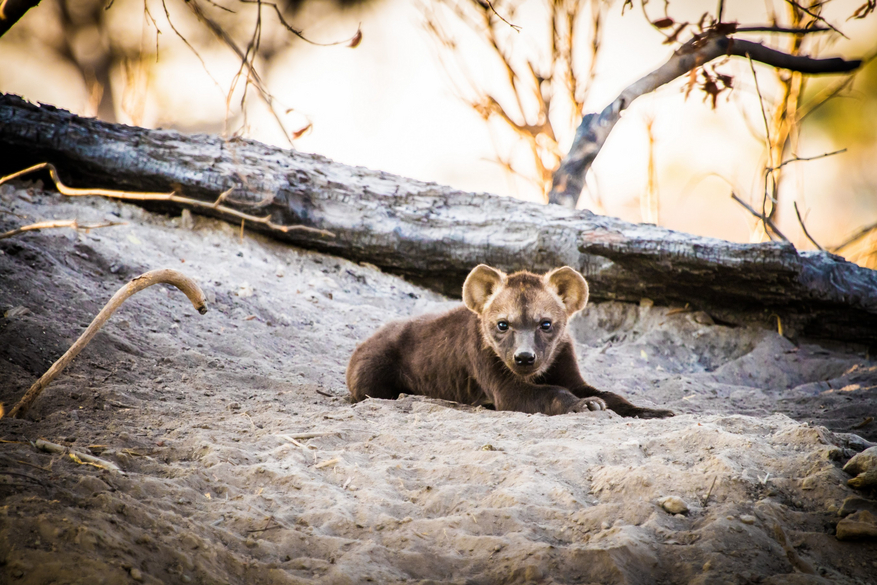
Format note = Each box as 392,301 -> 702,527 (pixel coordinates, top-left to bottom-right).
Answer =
548,32 -> 861,207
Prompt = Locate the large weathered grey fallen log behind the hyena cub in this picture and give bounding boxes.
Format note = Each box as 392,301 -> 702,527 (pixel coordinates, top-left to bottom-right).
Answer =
0,95 -> 877,344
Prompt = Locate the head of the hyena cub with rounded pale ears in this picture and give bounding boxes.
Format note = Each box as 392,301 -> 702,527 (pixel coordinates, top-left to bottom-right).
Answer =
463,264 -> 588,378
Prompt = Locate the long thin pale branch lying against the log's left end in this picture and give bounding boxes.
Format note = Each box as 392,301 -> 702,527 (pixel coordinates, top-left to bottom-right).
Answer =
0,163 -> 335,238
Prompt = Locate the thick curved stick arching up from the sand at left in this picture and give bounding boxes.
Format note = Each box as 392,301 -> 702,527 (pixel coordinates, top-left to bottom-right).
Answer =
9,268 -> 207,418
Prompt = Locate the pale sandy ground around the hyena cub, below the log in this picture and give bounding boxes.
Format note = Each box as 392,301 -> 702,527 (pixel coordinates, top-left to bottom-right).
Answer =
0,186 -> 877,584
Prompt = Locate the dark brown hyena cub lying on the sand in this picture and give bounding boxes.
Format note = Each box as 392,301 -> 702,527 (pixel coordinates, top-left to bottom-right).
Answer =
347,264 -> 673,418
